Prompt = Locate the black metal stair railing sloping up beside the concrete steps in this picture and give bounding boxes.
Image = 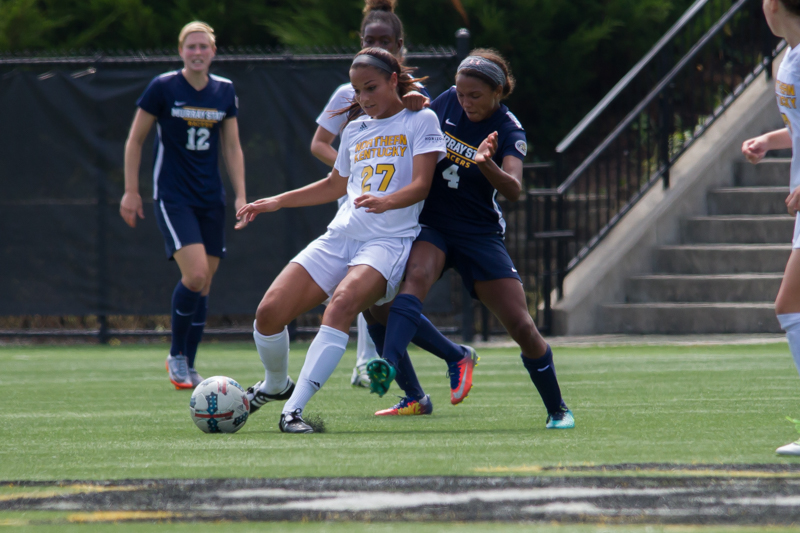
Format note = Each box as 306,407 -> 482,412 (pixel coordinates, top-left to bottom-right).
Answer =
528,0 -> 784,331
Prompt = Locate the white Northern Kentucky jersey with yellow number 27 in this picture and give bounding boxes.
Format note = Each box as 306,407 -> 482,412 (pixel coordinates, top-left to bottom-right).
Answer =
328,109 -> 447,241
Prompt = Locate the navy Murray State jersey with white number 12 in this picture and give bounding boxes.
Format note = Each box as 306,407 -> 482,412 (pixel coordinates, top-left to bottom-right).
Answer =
136,70 -> 238,207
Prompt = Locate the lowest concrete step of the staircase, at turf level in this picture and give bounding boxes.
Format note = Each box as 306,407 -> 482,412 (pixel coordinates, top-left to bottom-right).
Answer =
600,302 -> 781,335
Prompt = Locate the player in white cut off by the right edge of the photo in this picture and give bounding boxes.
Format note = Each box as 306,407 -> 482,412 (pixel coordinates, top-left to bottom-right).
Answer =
742,0 -> 800,455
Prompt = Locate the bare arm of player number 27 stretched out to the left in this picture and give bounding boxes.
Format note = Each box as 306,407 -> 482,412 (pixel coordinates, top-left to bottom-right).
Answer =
235,168 -> 347,229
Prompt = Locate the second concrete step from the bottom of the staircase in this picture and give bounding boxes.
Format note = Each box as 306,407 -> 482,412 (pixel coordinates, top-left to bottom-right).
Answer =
625,272 -> 783,303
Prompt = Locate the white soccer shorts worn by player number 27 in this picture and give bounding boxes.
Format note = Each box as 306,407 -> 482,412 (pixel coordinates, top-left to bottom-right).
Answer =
291,230 -> 414,305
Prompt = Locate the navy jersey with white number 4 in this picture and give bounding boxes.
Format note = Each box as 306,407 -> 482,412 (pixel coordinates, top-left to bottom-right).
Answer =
419,87 -> 527,234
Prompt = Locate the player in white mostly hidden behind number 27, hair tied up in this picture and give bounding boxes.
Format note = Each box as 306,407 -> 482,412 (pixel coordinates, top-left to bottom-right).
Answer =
311,0 -> 428,388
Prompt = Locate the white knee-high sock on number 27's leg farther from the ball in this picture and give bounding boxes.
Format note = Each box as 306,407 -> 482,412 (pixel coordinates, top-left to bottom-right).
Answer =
283,326 -> 350,413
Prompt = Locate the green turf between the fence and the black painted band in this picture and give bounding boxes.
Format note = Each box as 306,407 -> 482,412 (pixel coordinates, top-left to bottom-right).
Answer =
0,343 -> 800,480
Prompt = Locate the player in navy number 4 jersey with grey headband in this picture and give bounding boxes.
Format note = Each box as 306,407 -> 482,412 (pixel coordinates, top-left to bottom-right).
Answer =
367,49 -> 574,429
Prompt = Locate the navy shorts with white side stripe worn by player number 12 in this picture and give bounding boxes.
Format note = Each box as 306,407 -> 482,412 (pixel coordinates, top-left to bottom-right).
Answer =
153,200 -> 225,259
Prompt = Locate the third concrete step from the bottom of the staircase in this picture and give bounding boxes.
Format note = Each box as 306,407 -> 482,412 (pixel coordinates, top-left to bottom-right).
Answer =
653,244 -> 792,274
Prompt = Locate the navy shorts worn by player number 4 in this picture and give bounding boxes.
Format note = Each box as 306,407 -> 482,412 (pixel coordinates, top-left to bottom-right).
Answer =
414,226 -> 522,300
